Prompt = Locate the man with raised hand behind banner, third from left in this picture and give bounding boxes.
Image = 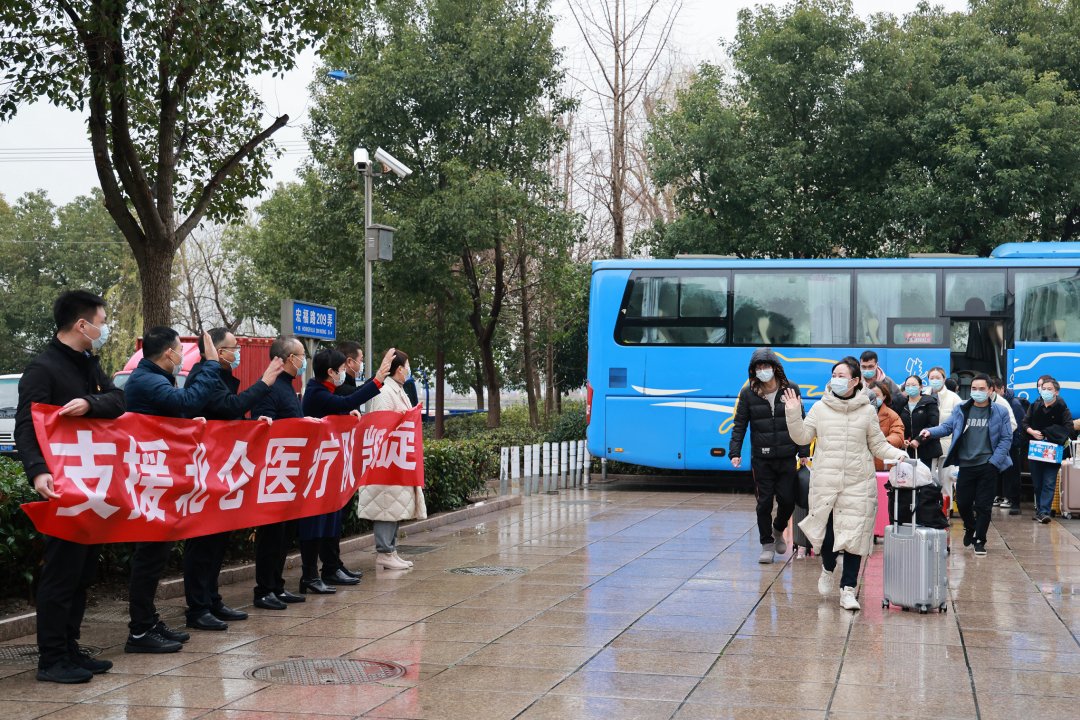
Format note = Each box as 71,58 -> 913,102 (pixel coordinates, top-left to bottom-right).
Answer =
184,327 -> 282,630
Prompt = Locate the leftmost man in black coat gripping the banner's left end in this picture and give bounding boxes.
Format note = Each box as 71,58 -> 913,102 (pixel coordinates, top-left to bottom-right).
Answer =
15,290 -> 124,683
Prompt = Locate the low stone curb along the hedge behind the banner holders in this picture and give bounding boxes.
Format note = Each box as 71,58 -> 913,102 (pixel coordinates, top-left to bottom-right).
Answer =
0,495 -> 522,641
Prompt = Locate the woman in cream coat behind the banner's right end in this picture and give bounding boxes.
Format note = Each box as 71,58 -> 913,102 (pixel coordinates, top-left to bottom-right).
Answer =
360,350 -> 428,570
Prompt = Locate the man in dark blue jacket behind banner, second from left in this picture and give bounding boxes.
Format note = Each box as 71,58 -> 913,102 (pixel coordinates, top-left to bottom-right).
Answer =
124,326 -> 224,653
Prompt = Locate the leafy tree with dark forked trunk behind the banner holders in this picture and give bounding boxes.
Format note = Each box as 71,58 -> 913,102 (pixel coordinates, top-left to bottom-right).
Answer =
0,0 -> 353,326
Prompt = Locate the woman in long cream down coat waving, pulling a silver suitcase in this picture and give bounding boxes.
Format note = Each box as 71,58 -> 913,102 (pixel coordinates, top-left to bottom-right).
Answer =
784,361 -> 907,610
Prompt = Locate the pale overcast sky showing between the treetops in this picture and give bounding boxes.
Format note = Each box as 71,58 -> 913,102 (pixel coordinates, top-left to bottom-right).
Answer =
0,0 -> 967,208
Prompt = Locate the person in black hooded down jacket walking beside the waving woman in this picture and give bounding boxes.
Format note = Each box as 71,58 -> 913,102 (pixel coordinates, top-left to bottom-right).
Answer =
728,348 -> 809,562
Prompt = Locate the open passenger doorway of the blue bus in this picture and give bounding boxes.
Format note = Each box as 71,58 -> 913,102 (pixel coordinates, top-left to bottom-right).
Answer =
943,268 -> 1009,398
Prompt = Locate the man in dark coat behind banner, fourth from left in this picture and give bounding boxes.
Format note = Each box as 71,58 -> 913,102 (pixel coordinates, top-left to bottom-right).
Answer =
252,335 -> 308,610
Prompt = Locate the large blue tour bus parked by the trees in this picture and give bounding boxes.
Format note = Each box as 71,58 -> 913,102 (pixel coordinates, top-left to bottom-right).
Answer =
588,243 -> 1080,471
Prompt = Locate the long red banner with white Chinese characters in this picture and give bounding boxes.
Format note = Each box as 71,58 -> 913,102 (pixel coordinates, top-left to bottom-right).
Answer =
23,404 -> 423,544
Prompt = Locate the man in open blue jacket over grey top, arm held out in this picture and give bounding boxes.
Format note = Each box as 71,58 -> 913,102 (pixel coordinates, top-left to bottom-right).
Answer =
919,372 -> 1012,555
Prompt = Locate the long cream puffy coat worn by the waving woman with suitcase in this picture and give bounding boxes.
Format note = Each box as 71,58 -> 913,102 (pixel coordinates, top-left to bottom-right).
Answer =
785,388 -> 907,556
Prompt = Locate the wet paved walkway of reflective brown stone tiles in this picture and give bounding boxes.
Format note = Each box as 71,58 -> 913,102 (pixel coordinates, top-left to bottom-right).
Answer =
0,489 -> 1080,720
